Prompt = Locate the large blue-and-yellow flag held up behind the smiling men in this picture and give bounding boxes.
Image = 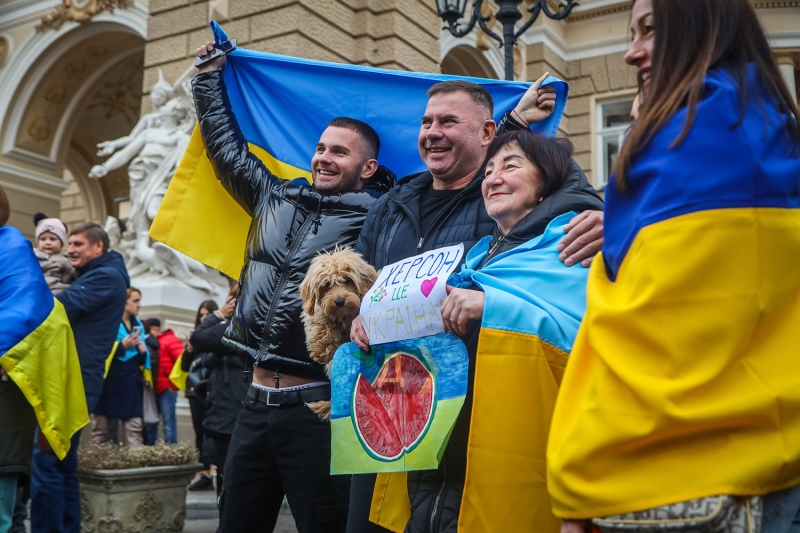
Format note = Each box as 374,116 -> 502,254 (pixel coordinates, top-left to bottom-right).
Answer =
150,23 -> 568,278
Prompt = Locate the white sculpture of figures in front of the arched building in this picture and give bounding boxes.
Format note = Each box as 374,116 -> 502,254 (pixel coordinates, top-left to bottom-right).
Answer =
89,69 -> 227,295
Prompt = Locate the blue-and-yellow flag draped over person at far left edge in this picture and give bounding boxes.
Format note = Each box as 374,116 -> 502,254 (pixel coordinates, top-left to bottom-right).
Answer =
0,226 -> 89,459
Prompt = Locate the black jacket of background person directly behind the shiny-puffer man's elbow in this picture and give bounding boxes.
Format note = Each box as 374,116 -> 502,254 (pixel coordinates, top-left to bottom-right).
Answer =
192,313 -> 253,435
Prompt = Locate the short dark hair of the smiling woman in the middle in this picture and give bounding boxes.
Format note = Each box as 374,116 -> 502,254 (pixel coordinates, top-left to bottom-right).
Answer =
486,129 -> 572,198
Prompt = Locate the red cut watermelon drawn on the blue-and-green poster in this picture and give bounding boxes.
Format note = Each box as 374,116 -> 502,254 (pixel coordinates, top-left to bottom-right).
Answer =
351,352 -> 436,461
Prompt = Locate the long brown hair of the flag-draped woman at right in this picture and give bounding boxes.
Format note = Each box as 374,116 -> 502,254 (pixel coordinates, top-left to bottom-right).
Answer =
614,0 -> 800,192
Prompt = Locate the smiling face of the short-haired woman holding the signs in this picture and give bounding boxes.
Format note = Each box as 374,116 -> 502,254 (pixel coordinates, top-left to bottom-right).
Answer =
481,142 -> 542,235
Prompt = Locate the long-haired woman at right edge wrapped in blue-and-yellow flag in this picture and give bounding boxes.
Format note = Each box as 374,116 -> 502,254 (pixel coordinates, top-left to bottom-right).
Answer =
547,0 -> 800,533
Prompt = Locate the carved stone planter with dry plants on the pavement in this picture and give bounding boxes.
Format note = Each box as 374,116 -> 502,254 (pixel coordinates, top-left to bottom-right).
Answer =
78,463 -> 203,533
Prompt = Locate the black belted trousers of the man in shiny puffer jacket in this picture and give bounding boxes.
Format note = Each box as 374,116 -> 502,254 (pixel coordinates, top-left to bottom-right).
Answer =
220,397 -> 350,533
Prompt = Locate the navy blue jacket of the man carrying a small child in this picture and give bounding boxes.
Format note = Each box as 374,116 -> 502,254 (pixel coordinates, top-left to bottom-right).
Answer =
56,251 -> 130,402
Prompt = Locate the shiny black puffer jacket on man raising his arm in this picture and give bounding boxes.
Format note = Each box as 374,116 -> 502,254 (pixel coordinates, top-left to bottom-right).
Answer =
192,71 -> 394,381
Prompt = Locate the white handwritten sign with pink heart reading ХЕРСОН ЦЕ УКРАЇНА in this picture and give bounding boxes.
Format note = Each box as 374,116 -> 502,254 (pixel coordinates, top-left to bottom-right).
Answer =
361,244 -> 464,345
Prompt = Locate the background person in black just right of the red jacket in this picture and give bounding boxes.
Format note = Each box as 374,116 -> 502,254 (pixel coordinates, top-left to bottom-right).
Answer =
181,300 -> 219,491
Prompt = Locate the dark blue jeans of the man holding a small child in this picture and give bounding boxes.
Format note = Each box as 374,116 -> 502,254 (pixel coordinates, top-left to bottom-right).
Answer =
31,396 -> 99,533
